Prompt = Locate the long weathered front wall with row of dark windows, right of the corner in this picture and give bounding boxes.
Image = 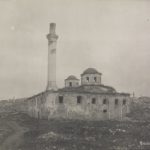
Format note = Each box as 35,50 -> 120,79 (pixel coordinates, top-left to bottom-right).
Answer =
45,92 -> 130,120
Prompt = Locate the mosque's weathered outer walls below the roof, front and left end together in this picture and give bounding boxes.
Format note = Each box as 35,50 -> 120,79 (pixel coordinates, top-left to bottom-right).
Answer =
28,92 -> 130,120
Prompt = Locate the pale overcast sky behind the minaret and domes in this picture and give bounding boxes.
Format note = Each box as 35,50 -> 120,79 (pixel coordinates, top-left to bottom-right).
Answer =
0,0 -> 150,100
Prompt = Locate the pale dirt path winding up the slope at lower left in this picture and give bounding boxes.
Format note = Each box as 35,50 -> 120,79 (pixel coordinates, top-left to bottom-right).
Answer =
0,121 -> 27,150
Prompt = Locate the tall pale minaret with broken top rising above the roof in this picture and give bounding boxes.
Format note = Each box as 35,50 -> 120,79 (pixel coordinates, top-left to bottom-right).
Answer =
46,23 -> 58,90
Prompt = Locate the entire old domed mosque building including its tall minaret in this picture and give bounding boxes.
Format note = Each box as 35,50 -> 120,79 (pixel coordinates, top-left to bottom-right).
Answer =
27,23 -> 131,120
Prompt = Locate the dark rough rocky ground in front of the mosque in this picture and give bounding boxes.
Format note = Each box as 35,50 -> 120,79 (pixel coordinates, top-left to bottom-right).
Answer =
0,97 -> 150,150
